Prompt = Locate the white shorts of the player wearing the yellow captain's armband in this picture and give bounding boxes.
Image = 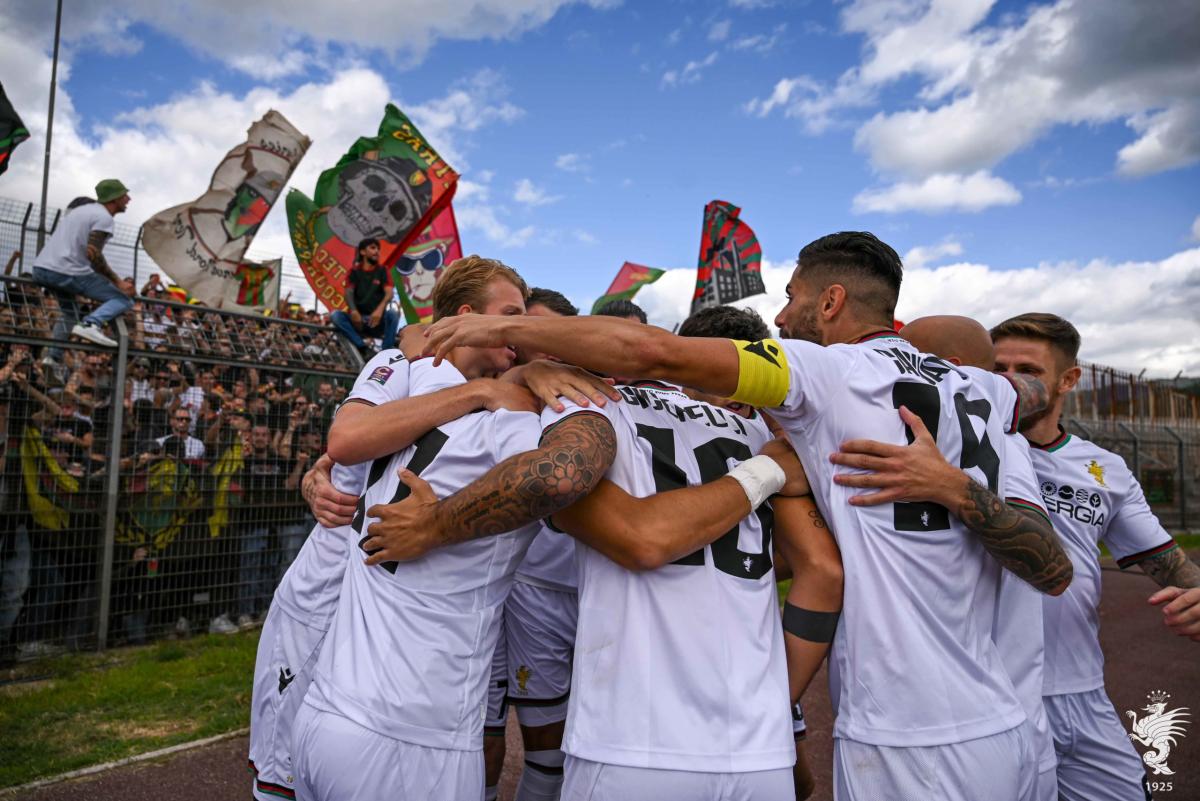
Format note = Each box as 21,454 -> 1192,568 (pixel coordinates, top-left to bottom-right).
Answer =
833,727 -> 1038,801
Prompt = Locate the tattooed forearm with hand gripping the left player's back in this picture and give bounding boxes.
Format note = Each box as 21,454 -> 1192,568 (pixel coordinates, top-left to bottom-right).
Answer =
362,414 -> 617,565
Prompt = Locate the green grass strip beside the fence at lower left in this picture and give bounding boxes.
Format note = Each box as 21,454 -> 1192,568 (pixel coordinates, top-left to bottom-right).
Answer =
0,631 -> 258,787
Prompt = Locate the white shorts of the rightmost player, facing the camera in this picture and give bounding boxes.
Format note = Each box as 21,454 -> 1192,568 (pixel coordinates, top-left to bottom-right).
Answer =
1042,689 -> 1150,801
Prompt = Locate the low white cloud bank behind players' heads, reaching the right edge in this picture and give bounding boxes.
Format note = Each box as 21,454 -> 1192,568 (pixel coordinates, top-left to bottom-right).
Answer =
635,248 -> 1200,377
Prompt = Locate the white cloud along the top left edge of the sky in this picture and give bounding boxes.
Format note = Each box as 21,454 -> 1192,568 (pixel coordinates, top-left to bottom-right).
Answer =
5,0 -> 614,79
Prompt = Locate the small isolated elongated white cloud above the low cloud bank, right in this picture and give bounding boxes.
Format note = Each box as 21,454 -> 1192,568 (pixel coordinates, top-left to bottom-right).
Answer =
853,170 -> 1021,213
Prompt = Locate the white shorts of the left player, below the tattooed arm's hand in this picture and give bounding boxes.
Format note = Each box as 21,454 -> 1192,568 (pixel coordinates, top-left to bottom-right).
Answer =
293,704 -> 484,801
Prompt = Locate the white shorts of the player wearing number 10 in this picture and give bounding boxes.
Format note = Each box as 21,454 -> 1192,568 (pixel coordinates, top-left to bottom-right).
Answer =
559,754 -> 796,801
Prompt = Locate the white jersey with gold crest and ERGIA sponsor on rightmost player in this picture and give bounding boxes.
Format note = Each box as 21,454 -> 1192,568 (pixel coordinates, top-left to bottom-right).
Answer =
1031,433 -> 1176,695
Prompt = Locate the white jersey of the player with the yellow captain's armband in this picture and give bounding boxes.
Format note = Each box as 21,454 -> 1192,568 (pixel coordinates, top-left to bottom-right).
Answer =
739,331 -> 1025,746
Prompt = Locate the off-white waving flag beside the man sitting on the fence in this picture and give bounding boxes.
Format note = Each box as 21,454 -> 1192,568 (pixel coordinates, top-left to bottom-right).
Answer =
142,110 -> 312,312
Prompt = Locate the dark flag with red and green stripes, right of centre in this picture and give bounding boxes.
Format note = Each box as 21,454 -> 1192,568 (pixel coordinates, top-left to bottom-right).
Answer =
691,200 -> 767,313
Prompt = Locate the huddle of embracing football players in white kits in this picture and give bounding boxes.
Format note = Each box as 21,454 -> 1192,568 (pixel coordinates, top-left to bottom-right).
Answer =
243,231 -> 1200,801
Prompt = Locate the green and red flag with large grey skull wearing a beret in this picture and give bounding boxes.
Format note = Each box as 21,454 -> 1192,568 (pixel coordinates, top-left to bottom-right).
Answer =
287,103 -> 458,311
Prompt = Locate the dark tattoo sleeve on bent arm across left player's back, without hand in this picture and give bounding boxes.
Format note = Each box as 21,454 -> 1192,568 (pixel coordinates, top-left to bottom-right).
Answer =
438,414 -> 617,544
